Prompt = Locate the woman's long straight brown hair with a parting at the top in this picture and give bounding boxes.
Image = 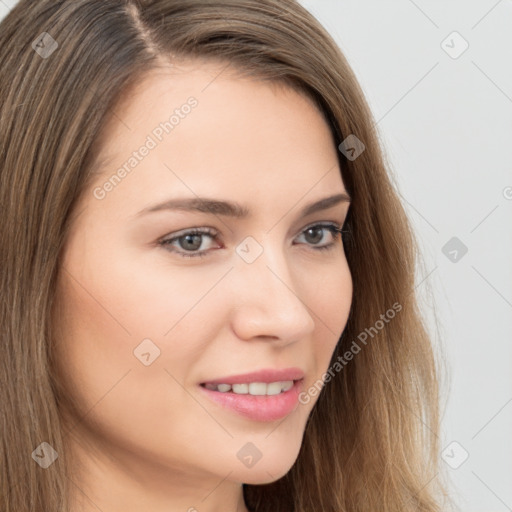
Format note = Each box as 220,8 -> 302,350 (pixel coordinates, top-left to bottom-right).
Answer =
0,0 -> 445,512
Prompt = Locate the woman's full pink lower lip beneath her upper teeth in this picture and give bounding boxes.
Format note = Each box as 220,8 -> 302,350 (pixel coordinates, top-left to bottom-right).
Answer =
199,379 -> 303,421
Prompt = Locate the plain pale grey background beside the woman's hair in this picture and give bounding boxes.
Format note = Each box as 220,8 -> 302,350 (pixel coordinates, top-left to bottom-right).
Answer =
0,0 -> 512,512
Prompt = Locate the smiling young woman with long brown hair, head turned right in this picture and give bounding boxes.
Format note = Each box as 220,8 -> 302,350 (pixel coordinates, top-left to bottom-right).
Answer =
0,0 -> 443,512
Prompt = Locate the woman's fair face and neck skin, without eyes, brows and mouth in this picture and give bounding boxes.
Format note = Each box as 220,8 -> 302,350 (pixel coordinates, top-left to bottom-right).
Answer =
55,61 -> 352,512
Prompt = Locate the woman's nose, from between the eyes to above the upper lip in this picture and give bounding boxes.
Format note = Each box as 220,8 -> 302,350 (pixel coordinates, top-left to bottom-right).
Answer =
230,242 -> 315,345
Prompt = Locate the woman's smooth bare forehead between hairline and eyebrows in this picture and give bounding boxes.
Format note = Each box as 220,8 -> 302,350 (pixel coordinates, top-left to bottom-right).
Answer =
86,62 -> 344,220
